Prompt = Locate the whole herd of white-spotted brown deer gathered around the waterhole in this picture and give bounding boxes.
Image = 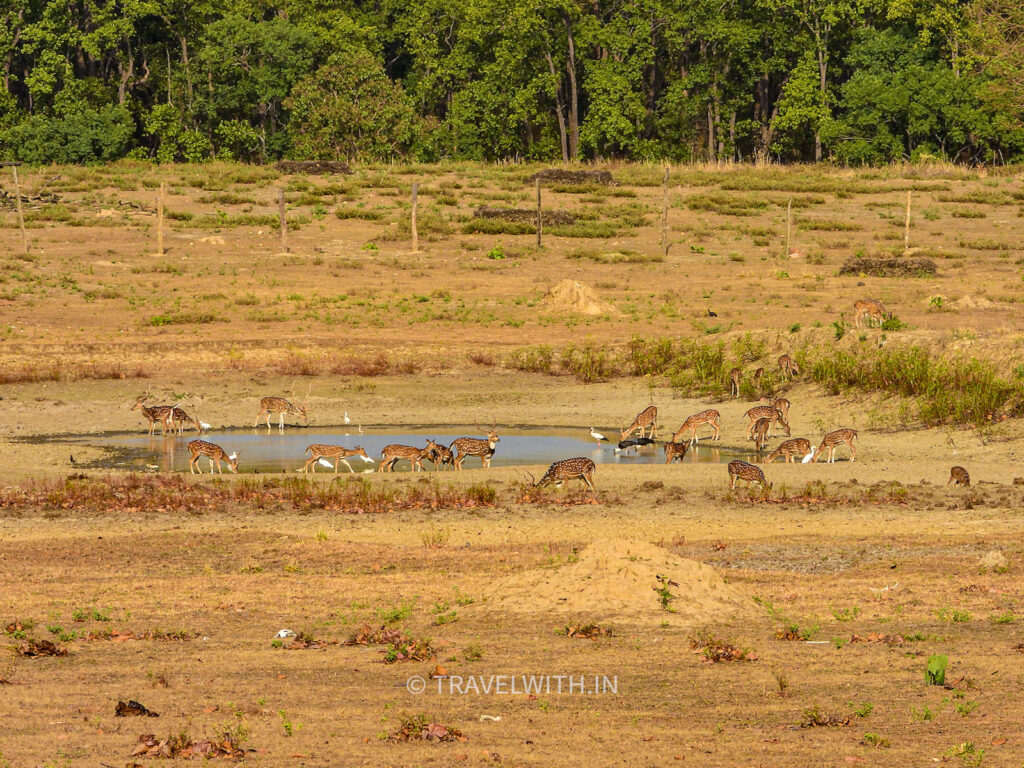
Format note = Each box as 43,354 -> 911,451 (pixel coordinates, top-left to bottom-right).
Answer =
125,299 -> 971,490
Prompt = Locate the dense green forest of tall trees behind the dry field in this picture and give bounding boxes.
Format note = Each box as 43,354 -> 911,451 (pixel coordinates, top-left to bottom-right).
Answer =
0,0 -> 1024,165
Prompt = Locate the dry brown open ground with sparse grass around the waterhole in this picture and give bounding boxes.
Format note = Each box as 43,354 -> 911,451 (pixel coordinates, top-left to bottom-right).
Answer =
0,159 -> 1024,768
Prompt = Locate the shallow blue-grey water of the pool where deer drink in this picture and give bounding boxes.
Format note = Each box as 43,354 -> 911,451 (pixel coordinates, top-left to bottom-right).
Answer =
74,426 -> 754,474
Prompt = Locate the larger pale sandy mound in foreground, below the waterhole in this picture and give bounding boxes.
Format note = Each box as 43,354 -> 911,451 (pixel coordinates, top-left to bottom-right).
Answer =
484,539 -> 751,626
